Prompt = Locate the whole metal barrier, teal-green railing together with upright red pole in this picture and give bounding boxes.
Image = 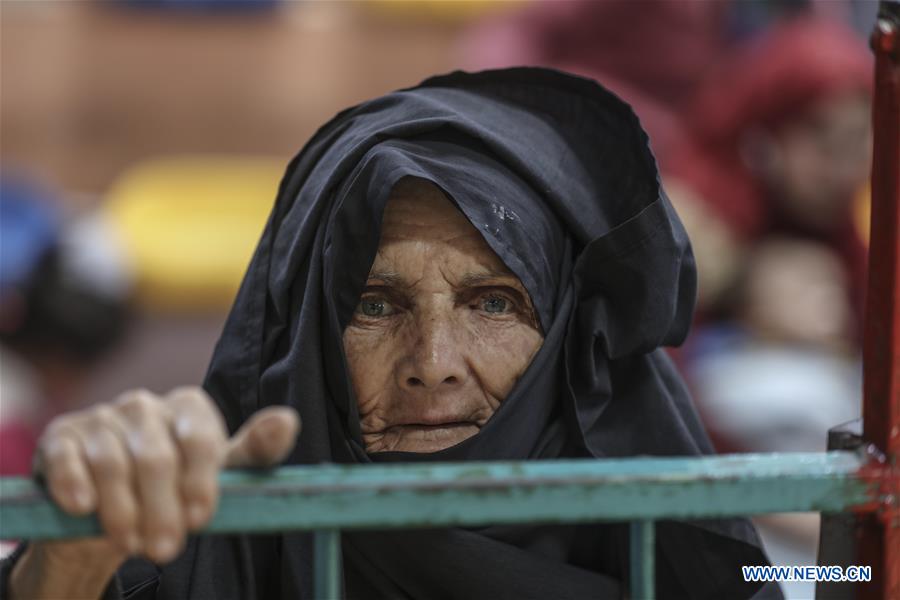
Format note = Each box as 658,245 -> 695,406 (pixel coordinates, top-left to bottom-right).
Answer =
0,0 -> 900,600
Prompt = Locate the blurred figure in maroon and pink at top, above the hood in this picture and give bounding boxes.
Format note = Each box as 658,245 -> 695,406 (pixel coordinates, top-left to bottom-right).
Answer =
460,0 -> 730,111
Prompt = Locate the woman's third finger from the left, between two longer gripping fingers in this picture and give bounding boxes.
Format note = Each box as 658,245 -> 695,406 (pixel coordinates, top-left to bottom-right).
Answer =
117,391 -> 185,563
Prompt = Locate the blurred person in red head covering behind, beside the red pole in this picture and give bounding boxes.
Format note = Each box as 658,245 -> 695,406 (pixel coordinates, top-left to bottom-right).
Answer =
666,20 -> 872,432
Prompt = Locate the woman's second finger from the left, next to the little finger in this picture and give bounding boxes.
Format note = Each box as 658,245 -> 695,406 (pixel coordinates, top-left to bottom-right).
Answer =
81,405 -> 141,554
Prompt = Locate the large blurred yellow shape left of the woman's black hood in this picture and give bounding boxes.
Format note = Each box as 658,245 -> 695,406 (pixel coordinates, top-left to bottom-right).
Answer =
107,155 -> 287,312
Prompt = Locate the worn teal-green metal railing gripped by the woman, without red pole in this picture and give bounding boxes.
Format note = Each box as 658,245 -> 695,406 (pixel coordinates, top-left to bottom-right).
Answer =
0,451 -> 885,599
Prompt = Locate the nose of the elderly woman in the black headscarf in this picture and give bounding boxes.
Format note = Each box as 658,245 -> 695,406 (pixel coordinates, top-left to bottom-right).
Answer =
400,315 -> 468,391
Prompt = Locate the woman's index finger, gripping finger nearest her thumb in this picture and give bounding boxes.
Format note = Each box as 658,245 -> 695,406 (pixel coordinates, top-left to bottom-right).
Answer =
165,388 -> 228,529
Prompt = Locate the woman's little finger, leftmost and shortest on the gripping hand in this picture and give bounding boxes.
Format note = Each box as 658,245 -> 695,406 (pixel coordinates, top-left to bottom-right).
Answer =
35,427 -> 97,515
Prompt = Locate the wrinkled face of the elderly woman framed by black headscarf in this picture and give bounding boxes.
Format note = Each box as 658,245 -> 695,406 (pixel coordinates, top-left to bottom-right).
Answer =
344,179 -> 543,453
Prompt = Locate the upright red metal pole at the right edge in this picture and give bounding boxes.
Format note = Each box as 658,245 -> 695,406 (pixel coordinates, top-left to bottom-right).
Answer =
858,0 -> 900,600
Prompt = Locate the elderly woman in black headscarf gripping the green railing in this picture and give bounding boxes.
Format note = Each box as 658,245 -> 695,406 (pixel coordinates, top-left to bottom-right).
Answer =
1,69 -> 766,600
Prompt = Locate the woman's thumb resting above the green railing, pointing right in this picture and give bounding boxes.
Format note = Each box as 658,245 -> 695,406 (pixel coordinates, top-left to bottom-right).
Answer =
225,406 -> 300,468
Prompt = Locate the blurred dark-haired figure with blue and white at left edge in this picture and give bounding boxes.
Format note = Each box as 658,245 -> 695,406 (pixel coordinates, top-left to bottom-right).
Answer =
0,173 -> 129,475
